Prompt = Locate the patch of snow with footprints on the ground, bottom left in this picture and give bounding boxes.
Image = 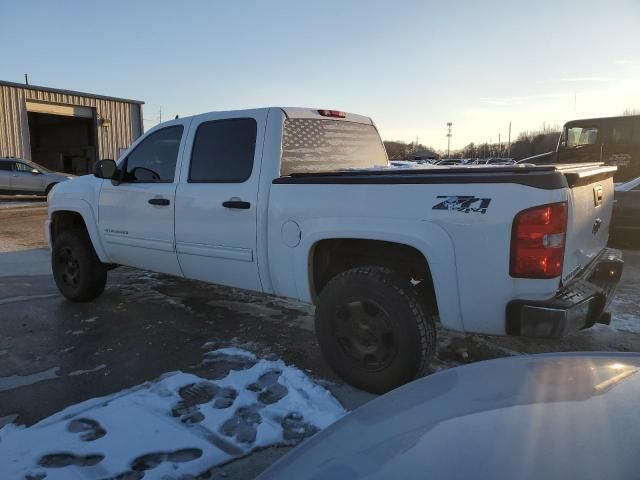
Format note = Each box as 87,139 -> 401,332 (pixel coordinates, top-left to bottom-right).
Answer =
0,348 -> 346,480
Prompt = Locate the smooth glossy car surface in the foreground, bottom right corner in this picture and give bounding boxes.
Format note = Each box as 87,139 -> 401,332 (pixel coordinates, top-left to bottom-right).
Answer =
258,353 -> 640,480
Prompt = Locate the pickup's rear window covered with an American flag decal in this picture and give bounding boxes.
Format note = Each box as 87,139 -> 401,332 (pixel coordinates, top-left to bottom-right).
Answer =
280,118 -> 388,175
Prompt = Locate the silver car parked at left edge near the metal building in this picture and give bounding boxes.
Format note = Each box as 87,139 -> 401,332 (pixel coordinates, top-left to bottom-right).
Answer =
0,157 -> 74,195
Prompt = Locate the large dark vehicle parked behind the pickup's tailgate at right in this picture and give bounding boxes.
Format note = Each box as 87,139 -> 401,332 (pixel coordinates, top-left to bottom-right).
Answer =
519,115 -> 640,182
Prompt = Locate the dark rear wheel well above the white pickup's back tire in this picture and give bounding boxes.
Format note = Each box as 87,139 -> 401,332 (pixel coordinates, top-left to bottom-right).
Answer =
309,238 -> 437,315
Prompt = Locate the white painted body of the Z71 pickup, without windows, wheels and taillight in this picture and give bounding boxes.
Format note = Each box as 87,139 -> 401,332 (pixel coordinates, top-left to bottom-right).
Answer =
47,108 -> 613,334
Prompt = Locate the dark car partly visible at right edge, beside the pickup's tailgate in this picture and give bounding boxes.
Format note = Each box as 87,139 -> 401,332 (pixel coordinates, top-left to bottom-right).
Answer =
610,177 -> 640,245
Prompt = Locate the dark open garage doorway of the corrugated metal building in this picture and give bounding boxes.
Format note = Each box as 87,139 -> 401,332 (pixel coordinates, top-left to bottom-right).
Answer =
27,112 -> 96,175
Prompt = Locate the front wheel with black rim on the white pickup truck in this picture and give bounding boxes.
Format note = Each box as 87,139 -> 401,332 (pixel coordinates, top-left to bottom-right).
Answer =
51,229 -> 107,302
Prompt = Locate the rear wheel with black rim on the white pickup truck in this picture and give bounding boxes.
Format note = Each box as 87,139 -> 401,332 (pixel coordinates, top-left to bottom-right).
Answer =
315,266 -> 436,393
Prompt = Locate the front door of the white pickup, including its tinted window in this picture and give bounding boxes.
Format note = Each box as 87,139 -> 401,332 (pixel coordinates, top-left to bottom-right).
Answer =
98,121 -> 188,275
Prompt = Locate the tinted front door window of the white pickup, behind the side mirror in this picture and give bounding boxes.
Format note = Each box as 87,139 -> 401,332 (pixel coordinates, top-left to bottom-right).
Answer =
123,125 -> 184,183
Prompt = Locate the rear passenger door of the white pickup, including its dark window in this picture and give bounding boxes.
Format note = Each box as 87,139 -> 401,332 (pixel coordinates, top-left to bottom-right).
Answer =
176,111 -> 266,291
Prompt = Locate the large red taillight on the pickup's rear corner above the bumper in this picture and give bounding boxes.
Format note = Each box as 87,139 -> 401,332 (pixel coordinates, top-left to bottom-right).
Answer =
509,202 -> 567,278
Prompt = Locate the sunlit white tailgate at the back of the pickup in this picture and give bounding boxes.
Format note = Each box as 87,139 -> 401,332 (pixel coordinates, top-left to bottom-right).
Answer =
557,164 -> 616,284
